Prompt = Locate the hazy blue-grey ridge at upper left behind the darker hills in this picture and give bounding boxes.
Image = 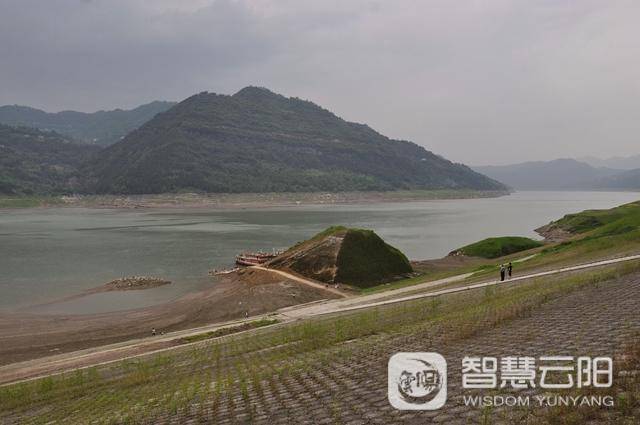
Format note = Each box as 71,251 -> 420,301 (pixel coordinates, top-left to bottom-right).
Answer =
0,101 -> 175,146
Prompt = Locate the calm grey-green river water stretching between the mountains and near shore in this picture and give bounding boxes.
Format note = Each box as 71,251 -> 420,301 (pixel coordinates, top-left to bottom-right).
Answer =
0,192 -> 640,313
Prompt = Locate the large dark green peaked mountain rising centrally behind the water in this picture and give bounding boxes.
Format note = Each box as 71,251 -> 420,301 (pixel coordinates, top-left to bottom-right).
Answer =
83,87 -> 506,194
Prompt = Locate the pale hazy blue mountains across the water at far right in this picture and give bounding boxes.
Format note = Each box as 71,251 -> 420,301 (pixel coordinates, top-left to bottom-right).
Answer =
472,159 -> 640,190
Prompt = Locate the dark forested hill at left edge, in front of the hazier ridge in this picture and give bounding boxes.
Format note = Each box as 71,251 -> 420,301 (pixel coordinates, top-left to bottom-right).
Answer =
0,124 -> 100,195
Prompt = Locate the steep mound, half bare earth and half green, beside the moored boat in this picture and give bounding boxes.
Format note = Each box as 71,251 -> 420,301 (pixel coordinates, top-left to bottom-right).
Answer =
269,226 -> 413,288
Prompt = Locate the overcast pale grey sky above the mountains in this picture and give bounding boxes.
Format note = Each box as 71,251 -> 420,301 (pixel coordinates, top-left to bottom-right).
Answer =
0,0 -> 640,165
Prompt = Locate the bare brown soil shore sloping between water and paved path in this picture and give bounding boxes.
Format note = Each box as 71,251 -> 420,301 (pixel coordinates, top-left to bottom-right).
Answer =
0,270 -> 339,364
